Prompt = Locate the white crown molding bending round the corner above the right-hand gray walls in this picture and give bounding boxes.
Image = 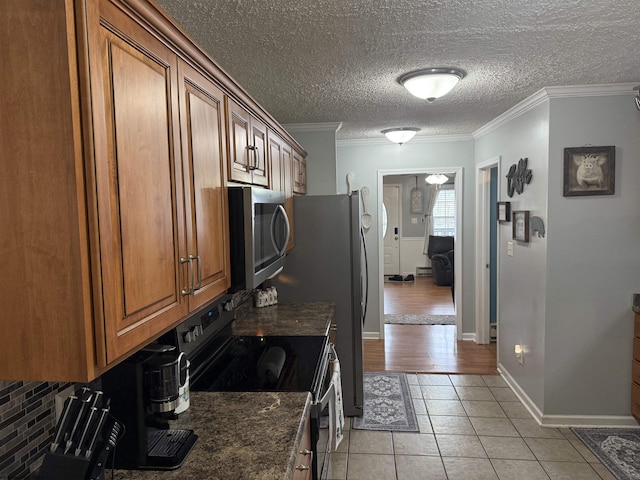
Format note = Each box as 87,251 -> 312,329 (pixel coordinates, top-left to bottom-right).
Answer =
472,83 -> 636,139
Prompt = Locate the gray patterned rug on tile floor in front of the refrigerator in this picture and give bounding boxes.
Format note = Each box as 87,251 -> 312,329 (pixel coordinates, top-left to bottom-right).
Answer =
353,372 -> 420,432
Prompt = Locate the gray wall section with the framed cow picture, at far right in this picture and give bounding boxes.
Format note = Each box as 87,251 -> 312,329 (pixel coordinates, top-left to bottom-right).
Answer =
544,95 -> 640,415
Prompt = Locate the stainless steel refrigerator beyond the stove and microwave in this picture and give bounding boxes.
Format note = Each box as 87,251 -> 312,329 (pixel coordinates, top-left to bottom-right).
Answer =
272,191 -> 368,416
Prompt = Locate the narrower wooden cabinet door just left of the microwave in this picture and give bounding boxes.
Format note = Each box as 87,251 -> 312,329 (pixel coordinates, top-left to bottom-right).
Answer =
179,61 -> 230,310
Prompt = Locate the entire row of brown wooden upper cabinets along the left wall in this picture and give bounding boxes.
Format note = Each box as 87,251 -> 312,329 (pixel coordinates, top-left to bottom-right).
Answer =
0,0 -> 306,382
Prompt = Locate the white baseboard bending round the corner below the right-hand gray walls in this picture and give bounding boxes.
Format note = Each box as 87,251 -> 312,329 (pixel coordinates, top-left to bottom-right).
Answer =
498,364 -> 638,428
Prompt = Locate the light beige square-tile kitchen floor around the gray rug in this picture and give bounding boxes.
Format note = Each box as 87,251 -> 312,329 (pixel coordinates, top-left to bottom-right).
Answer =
328,374 -> 615,480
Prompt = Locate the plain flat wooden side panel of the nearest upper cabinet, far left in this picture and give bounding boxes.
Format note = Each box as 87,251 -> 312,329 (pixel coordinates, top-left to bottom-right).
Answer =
0,0 -> 95,381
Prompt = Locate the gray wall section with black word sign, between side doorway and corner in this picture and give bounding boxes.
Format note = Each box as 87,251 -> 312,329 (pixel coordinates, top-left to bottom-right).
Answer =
475,101 -> 549,409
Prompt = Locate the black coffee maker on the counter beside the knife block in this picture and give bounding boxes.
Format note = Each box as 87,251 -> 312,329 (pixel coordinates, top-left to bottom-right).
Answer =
101,344 -> 198,470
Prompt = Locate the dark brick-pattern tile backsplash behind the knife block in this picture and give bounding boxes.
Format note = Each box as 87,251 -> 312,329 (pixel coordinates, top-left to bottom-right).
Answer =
0,381 -> 73,480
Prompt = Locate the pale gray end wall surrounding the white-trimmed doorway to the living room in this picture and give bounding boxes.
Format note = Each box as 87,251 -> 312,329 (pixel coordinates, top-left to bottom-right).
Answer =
337,140 -> 475,336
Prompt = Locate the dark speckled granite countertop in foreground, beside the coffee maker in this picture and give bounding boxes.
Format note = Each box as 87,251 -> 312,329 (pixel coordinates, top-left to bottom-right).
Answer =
112,392 -> 311,480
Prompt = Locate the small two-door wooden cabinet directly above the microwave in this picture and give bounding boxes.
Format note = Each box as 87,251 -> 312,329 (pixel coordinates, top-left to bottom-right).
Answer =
227,98 -> 270,187
